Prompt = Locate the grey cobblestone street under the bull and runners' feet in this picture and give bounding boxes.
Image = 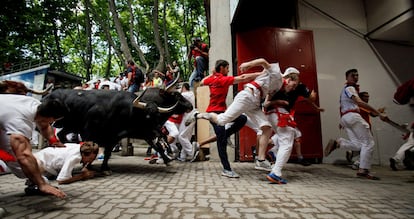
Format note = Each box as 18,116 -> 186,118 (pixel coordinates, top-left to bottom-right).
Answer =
0,148 -> 414,219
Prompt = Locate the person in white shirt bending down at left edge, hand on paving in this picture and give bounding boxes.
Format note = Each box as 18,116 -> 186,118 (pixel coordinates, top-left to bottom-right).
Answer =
0,94 -> 66,198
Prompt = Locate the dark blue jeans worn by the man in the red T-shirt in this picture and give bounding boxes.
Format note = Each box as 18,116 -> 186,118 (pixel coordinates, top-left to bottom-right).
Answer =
211,115 -> 247,171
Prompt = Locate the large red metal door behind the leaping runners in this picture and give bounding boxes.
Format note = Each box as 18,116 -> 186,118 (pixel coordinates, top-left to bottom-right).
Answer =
236,27 -> 323,162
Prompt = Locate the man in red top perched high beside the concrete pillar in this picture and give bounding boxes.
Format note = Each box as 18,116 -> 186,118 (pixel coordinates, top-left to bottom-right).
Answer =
188,37 -> 209,88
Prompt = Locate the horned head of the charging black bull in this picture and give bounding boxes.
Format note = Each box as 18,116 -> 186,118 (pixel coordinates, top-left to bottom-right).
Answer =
133,74 -> 192,113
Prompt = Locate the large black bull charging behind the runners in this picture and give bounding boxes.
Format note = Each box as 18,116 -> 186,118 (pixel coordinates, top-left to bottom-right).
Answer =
42,88 -> 193,171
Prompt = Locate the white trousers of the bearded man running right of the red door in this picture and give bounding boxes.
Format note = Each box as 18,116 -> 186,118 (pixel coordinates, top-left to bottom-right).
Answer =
338,112 -> 375,169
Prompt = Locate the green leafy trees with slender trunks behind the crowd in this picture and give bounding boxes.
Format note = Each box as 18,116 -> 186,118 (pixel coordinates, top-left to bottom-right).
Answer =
0,0 -> 208,79
